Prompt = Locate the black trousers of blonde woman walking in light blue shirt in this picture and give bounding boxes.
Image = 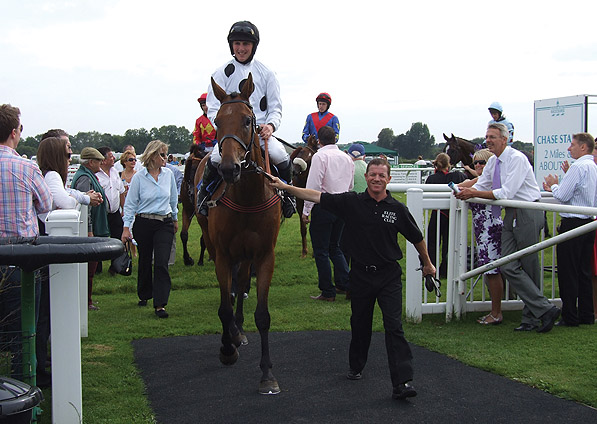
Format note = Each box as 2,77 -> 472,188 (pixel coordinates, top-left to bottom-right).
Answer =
133,216 -> 174,308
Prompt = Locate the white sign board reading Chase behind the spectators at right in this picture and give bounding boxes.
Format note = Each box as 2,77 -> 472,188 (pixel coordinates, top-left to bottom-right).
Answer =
534,95 -> 587,187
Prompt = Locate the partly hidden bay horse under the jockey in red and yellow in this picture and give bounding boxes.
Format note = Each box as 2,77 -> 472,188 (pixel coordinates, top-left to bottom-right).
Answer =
180,144 -> 206,266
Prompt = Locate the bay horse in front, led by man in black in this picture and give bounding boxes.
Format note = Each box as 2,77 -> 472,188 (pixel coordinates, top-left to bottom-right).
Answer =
195,74 -> 281,394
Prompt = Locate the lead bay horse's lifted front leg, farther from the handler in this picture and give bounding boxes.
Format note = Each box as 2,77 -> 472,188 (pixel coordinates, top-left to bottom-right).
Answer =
216,253 -> 241,365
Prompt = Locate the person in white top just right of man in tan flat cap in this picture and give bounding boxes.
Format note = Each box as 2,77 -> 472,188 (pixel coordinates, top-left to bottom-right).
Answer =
95,146 -> 124,276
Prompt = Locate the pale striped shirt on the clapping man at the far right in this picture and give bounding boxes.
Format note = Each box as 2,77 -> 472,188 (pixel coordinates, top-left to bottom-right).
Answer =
551,155 -> 597,218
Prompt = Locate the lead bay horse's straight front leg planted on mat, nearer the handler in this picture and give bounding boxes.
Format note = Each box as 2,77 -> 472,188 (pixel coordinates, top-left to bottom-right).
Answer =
255,252 -> 280,395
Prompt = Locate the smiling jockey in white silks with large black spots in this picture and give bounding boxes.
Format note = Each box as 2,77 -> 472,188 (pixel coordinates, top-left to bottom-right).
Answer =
197,21 -> 296,218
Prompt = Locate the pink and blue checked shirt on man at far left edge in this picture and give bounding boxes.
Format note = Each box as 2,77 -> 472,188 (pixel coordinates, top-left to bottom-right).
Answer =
0,144 -> 52,237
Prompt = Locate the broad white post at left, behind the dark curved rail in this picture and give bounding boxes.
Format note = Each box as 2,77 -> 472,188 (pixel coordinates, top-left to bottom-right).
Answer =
45,209 -> 87,424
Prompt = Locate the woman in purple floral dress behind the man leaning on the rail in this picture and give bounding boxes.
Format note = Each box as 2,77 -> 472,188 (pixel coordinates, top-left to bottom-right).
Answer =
459,149 -> 504,325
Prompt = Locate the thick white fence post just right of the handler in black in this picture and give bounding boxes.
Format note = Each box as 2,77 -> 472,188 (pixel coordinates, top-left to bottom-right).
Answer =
406,188 -> 423,323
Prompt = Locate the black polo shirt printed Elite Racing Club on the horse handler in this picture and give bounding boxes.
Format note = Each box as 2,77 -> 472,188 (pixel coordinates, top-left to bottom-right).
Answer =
321,190 -> 423,266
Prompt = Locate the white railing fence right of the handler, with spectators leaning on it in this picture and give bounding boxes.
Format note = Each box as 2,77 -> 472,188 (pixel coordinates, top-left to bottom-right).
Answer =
388,184 -> 597,322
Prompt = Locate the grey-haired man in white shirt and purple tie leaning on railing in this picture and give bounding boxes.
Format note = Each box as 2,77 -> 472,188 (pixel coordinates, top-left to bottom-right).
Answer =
456,124 -> 560,333
